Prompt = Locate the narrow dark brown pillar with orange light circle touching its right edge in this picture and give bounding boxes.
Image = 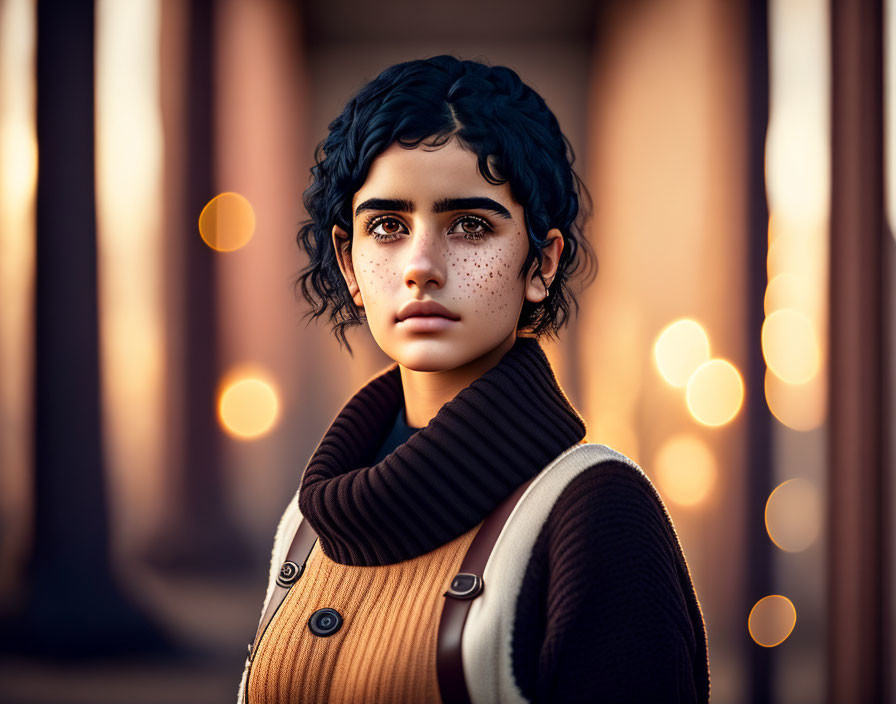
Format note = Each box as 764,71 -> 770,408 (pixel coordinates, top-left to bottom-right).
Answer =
145,0 -> 252,574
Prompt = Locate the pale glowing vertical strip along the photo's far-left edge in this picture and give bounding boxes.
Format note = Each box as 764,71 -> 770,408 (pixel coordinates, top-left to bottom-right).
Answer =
0,0 -> 37,587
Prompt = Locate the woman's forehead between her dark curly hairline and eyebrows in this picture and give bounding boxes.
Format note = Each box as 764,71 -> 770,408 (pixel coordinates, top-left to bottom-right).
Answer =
352,139 -> 521,217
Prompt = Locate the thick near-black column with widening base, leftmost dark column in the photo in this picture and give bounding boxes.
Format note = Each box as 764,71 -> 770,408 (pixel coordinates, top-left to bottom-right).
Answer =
3,0 -> 161,656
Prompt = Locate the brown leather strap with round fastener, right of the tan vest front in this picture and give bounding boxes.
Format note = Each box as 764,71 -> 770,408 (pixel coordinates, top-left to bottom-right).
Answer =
436,477 -> 535,704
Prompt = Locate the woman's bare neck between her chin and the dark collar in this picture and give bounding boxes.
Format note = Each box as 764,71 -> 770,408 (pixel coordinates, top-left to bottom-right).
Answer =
398,330 -> 516,428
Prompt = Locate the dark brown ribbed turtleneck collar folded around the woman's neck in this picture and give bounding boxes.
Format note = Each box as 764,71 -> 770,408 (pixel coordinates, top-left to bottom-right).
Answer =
299,337 -> 585,565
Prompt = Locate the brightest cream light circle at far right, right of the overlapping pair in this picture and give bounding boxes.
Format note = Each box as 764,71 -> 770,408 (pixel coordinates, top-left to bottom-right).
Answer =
762,308 -> 821,384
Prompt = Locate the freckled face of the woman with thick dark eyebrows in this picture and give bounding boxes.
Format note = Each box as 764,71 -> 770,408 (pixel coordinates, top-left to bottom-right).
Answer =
333,139 -> 562,371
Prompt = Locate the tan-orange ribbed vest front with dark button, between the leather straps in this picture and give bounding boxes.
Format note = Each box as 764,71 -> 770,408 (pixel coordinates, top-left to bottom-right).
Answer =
249,523 -> 482,704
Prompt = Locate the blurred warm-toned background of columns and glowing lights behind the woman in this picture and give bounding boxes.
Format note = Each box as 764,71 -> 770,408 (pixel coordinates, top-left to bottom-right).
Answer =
0,0 -> 896,704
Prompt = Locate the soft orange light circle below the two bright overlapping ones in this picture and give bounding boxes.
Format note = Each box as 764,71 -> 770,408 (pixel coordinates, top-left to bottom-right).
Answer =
654,434 -> 717,506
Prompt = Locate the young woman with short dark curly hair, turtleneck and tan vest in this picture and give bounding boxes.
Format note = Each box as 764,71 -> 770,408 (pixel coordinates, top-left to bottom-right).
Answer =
240,56 -> 709,704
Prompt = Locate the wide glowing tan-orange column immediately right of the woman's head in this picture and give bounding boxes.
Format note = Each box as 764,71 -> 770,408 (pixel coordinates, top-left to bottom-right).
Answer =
580,0 -> 752,702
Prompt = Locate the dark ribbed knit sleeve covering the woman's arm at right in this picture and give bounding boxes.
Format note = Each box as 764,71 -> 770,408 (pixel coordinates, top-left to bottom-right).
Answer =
513,462 -> 710,704
